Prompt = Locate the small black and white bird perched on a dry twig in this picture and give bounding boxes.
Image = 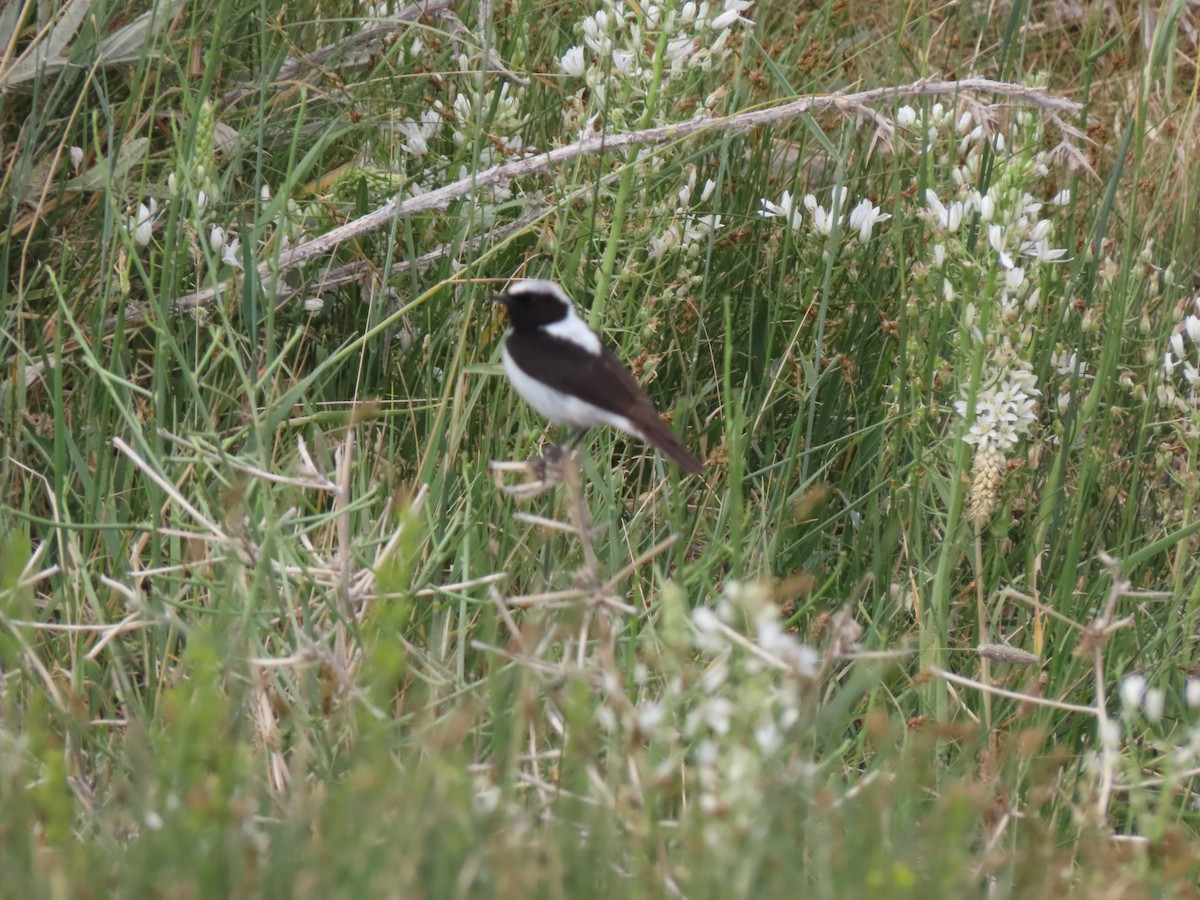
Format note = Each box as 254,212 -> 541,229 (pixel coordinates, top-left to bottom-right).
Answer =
494,280 -> 704,475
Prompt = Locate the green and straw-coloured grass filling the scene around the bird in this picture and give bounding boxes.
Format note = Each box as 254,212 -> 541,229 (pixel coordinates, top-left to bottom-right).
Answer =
0,0 -> 1200,898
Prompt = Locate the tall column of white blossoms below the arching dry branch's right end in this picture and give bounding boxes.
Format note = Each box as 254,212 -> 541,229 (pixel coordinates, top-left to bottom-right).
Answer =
895,103 -> 1070,522
